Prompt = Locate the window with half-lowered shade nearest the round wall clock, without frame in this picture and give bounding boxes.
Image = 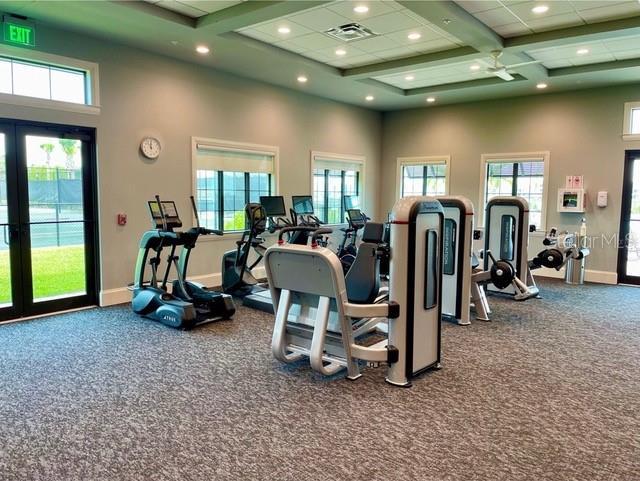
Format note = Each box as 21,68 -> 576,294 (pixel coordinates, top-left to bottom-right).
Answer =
194,139 -> 277,232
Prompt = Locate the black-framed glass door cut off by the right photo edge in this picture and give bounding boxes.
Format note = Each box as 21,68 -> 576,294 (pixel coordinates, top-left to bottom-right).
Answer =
618,150 -> 640,284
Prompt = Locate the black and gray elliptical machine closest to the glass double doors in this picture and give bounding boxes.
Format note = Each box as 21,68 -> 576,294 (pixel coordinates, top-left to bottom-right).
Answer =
131,195 -> 235,329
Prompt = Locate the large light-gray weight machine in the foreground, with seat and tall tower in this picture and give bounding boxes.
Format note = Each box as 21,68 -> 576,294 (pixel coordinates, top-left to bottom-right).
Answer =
265,197 -> 444,386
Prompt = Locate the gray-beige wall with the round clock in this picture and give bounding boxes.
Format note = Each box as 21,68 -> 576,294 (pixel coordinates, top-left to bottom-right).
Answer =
0,27 -> 381,289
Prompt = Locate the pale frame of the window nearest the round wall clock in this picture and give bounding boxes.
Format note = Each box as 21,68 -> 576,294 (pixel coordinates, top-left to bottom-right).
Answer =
191,137 -> 280,242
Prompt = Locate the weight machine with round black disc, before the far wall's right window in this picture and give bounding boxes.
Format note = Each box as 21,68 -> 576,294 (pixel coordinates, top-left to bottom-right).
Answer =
483,196 -> 539,301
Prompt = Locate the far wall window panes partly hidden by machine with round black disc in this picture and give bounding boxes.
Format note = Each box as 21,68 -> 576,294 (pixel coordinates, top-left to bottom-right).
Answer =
484,159 -> 545,229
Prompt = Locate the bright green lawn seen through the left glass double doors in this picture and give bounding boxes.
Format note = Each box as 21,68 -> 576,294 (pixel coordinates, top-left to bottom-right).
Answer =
0,246 -> 85,304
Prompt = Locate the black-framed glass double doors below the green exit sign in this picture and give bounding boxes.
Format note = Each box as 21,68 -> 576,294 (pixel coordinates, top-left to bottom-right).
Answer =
0,120 -> 98,321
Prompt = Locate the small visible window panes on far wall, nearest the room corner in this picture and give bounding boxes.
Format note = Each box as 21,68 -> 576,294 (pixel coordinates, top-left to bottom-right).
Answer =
398,157 -> 449,197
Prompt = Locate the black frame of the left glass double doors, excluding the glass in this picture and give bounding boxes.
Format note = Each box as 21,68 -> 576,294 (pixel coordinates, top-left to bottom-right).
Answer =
0,118 -> 100,320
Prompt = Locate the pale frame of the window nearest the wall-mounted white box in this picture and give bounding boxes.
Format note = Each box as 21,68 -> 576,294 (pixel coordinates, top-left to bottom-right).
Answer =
477,150 -> 551,235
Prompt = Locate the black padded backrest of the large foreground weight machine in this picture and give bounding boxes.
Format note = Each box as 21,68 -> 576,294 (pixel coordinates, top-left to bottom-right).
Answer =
345,242 -> 380,304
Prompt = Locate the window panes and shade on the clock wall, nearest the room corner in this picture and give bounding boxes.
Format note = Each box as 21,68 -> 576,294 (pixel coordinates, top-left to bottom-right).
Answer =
312,154 -> 363,224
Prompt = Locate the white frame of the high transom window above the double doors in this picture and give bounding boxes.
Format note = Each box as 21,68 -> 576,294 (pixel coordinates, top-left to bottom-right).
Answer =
0,45 -> 100,115
